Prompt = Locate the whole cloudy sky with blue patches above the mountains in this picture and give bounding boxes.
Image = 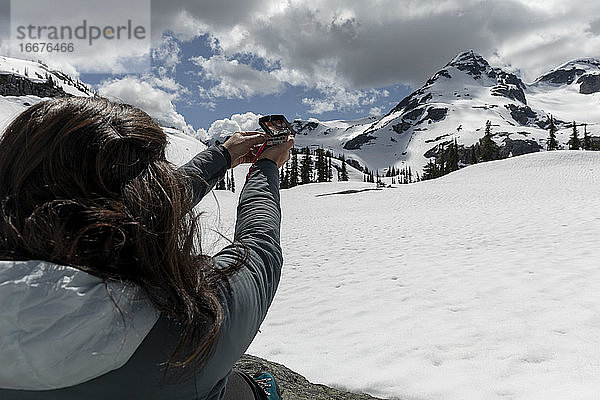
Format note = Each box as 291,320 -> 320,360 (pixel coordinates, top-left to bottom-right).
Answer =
1,0 -> 600,138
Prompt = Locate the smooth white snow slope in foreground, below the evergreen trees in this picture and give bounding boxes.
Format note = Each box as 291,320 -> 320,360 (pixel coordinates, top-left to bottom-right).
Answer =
193,151 -> 600,400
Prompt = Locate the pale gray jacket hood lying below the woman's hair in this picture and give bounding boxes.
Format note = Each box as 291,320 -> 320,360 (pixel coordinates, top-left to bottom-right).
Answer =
0,261 -> 159,390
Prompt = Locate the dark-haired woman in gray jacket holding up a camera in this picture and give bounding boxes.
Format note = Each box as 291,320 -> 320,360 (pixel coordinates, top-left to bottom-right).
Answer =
0,98 -> 293,399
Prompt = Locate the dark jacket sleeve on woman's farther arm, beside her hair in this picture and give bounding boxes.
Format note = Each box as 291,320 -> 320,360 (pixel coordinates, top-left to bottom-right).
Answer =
179,144 -> 231,205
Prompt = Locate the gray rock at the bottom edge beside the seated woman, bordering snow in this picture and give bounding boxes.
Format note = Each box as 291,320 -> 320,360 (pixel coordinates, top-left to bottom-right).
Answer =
233,354 -> 390,400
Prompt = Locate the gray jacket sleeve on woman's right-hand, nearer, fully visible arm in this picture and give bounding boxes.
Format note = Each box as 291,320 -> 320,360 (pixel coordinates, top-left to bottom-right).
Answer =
207,159 -> 283,378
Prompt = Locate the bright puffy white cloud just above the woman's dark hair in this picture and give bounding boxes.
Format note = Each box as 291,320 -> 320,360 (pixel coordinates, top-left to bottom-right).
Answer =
98,76 -> 196,135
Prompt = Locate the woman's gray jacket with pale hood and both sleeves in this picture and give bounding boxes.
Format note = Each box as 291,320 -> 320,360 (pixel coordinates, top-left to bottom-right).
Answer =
0,146 -> 283,400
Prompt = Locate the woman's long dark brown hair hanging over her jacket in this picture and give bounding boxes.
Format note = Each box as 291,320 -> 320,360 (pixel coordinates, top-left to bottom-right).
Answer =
0,97 -> 237,376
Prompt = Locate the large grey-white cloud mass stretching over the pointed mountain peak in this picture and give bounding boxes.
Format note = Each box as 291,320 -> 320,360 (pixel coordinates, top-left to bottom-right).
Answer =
155,0 -> 600,94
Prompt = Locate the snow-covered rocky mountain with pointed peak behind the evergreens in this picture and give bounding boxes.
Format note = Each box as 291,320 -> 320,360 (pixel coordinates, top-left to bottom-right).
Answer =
294,50 -> 600,171
